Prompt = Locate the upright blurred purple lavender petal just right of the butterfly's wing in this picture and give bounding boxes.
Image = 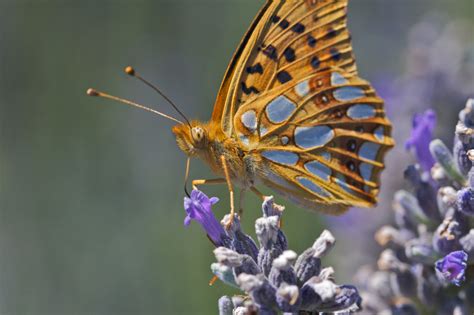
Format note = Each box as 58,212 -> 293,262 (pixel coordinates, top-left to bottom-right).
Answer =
405,109 -> 436,172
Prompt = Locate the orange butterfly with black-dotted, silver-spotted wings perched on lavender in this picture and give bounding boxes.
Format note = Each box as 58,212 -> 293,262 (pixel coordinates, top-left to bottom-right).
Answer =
88,0 -> 394,222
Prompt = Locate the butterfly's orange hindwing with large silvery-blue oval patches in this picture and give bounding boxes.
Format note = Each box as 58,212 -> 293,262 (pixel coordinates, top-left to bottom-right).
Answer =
234,67 -> 393,212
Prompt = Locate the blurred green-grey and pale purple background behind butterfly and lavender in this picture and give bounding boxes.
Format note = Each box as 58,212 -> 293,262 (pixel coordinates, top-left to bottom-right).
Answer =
0,0 -> 474,315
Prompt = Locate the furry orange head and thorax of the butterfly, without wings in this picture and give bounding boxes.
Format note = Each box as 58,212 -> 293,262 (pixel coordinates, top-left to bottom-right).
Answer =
173,121 -> 257,188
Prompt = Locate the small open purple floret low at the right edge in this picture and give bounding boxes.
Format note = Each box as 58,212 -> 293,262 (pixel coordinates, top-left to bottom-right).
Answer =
435,250 -> 468,286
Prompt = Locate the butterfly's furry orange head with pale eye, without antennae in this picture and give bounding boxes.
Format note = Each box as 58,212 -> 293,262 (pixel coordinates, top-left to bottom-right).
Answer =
172,121 -> 209,156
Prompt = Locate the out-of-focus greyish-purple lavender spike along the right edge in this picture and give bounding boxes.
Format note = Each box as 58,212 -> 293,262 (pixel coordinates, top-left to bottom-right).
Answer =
356,102 -> 474,315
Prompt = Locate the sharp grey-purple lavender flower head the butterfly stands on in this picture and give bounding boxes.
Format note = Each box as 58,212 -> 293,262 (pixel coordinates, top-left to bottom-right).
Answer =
185,196 -> 361,315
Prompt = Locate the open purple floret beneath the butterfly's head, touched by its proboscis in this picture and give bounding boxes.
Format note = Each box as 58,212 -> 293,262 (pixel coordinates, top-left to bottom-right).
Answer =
184,189 -> 225,246
